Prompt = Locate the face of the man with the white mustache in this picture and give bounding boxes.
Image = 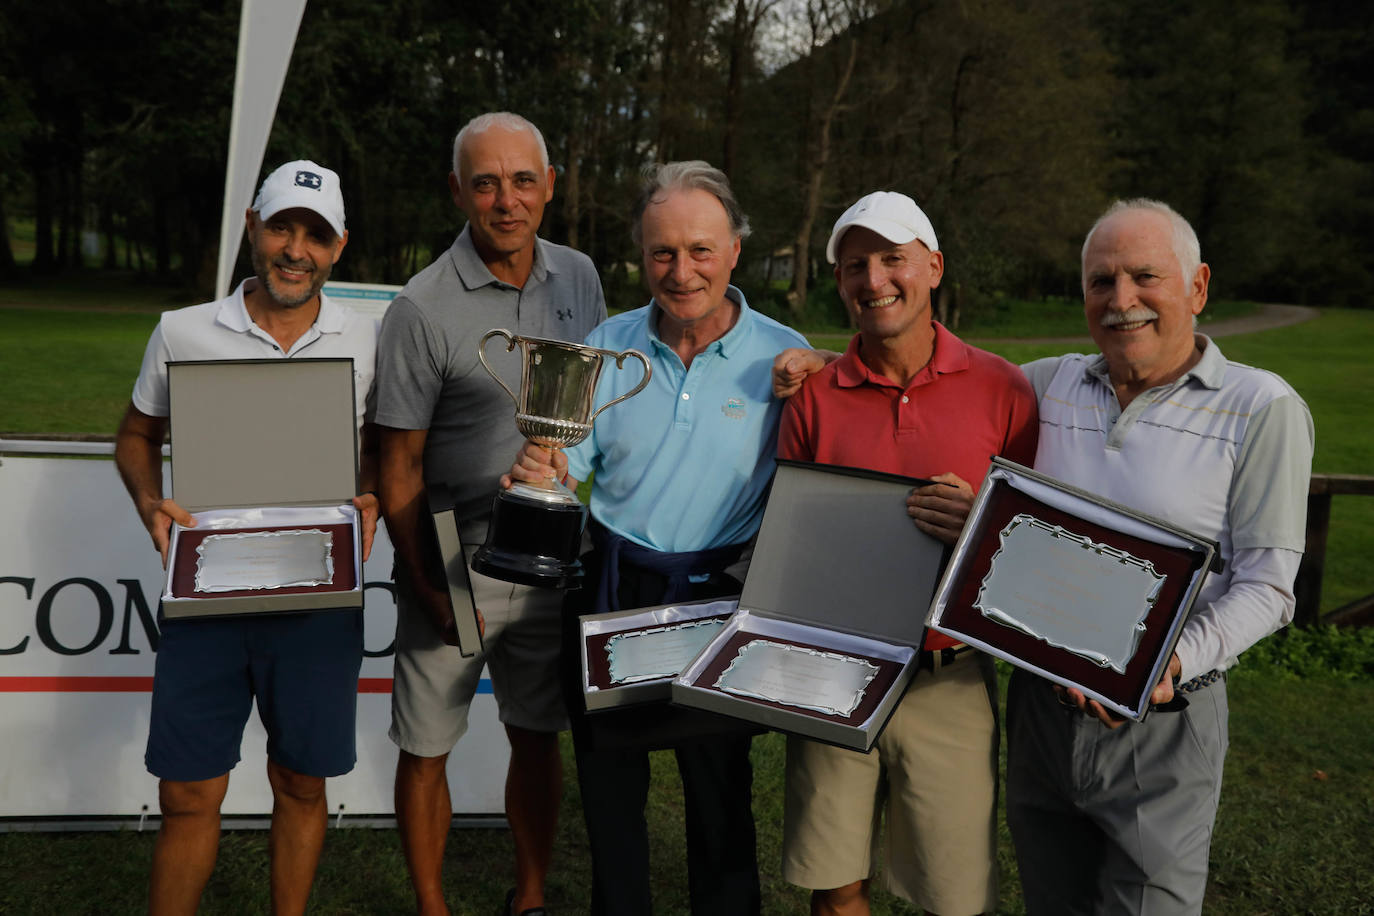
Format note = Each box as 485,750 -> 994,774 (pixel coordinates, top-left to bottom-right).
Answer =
1083,210 -> 1210,390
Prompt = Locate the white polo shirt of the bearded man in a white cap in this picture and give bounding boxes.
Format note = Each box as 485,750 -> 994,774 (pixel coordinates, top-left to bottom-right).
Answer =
133,277 -> 376,426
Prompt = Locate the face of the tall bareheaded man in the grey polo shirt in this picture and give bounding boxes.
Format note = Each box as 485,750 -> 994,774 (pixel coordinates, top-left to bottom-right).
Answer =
448,126 -> 554,262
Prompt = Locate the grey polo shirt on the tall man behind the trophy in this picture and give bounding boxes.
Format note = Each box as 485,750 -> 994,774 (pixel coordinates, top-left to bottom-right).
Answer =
374,227 -> 606,542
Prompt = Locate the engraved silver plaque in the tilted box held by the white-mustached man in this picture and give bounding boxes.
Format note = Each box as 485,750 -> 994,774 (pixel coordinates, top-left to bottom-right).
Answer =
974,514 -> 1165,674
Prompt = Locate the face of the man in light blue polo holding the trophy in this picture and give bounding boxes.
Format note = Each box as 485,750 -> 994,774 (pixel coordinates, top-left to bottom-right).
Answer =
640,188 -> 739,334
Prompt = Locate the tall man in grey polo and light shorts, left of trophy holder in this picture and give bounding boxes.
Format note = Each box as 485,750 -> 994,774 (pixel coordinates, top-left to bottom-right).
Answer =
375,113 -> 606,913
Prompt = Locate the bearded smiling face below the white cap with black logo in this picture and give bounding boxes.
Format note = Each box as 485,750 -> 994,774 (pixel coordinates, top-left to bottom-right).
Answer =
247,207 -> 348,309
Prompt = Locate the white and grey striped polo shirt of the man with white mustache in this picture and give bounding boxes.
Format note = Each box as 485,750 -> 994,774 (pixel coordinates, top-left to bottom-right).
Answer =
1022,334 -> 1314,681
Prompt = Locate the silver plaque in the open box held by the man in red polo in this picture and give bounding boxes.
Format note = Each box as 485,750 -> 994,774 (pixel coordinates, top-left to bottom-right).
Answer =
714,639 -> 878,717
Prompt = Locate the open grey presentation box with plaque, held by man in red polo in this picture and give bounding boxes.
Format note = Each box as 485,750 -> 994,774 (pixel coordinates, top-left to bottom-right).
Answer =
672,461 -> 944,750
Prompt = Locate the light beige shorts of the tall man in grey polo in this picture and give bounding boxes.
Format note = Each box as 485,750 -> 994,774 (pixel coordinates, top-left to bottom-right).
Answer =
389,547 -> 567,757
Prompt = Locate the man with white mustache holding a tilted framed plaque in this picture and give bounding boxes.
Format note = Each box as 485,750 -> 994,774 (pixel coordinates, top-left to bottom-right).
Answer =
1007,199 -> 1312,913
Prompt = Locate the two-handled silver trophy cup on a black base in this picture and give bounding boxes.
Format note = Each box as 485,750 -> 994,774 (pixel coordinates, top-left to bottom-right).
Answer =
473,328 -> 653,588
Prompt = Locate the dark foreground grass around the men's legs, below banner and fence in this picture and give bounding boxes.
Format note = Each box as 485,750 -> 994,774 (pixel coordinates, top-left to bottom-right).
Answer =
0,670 -> 1374,916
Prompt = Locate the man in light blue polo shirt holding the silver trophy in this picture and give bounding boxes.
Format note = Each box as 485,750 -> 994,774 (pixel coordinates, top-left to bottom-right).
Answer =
507,162 -> 807,916
